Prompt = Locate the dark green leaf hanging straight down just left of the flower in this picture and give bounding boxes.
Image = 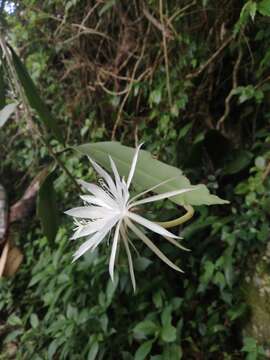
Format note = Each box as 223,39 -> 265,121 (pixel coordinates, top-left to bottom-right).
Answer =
37,173 -> 58,243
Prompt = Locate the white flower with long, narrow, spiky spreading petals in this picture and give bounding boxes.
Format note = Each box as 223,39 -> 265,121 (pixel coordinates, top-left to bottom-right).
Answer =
66,145 -> 192,290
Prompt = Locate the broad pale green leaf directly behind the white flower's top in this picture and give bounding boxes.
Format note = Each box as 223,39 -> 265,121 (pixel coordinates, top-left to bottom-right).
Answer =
75,141 -> 228,205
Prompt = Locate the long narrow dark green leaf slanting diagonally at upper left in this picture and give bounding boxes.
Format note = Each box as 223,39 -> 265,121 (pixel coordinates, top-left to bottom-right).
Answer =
9,46 -> 63,142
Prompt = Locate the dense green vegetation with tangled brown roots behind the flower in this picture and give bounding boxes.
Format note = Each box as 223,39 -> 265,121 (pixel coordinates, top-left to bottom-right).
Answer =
0,0 -> 270,360
